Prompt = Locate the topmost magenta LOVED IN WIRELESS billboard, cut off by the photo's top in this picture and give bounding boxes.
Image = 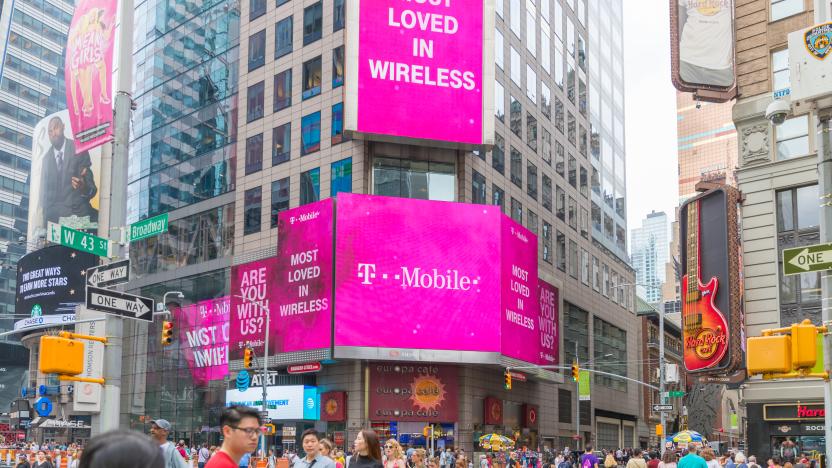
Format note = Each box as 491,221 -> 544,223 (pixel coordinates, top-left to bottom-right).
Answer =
345,0 -> 494,145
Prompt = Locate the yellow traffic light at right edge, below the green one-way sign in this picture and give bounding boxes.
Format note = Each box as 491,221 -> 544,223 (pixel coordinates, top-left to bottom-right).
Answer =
746,319 -> 826,378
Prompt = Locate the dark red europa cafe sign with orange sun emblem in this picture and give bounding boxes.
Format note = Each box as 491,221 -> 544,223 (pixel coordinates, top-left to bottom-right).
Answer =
370,363 -> 459,422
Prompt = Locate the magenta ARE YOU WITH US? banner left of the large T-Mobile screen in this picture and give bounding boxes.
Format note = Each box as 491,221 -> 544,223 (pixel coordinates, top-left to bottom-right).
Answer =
228,257 -> 277,359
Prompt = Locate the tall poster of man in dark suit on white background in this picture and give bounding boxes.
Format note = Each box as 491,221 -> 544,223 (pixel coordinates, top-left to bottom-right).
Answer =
29,110 -> 102,239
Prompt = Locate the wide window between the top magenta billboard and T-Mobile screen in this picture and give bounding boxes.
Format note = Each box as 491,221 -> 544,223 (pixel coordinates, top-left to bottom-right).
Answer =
372,157 -> 456,201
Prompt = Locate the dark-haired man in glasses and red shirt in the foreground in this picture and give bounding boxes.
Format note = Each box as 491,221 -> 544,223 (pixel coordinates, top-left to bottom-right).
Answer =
205,406 -> 262,468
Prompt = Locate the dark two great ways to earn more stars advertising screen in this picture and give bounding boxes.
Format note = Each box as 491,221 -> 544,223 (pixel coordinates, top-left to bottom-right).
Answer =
15,245 -> 98,318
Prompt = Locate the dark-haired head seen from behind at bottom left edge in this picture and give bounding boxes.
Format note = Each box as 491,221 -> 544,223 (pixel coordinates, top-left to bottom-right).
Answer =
78,431 -> 165,468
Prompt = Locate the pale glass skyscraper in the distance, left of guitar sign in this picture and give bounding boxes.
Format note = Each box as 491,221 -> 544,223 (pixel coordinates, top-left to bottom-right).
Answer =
630,211 -> 670,303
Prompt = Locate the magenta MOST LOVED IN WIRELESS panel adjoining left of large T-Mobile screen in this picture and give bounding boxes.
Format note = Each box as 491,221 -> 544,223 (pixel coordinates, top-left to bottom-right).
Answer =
276,198 -> 333,353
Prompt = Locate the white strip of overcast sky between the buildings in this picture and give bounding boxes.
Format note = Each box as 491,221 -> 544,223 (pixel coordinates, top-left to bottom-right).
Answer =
622,0 -> 679,246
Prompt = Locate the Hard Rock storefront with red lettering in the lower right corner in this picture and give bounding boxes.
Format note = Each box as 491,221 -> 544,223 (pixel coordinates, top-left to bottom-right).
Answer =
747,402 -> 826,463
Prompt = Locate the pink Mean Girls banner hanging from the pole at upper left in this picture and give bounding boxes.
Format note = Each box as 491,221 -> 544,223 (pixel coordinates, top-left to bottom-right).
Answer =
64,0 -> 118,153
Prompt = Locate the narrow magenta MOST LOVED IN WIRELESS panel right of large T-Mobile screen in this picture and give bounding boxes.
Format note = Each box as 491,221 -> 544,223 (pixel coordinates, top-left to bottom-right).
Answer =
500,216 -> 543,364
